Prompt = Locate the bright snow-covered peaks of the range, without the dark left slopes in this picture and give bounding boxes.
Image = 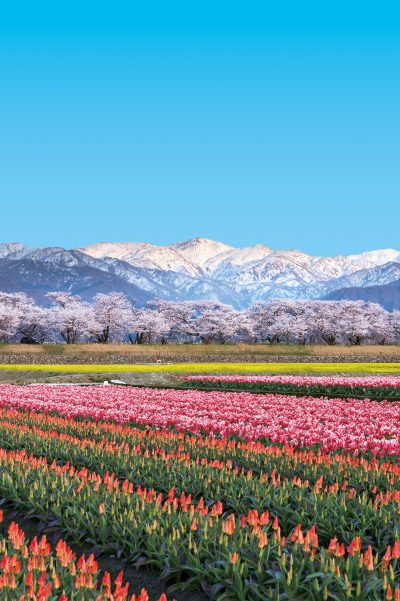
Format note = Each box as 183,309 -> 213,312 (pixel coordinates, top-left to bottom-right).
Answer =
80,238 -> 400,303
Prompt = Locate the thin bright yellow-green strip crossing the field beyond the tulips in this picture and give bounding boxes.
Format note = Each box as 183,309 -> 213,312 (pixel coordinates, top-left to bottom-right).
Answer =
0,363 -> 400,373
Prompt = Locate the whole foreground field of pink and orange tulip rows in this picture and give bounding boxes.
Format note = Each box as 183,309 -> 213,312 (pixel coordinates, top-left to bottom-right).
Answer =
0,377 -> 400,601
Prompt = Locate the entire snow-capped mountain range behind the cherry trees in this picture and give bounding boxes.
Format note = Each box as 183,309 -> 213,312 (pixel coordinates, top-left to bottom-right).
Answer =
0,238 -> 400,310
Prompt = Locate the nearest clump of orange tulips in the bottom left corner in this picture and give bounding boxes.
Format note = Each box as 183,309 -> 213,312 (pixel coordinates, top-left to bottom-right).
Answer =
0,511 -> 167,601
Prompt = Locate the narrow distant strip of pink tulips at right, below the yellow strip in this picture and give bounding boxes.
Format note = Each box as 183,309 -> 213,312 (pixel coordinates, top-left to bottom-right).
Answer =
182,375 -> 400,399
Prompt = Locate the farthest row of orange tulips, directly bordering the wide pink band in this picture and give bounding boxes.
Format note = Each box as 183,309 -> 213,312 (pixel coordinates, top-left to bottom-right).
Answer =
0,409 -> 400,495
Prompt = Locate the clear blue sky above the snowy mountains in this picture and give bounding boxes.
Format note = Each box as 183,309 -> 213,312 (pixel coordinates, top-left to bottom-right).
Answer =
0,0 -> 400,255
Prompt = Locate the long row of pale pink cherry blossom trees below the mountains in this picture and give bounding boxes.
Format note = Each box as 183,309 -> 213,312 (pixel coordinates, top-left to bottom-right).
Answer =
0,292 -> 400,345
